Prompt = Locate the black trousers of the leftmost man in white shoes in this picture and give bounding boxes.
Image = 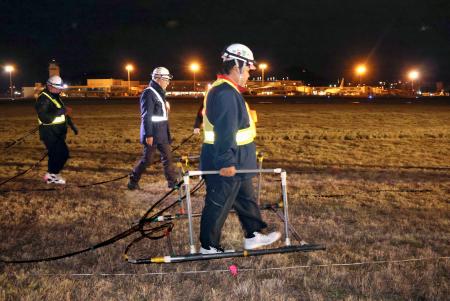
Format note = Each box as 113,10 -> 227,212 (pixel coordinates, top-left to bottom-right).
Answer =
42,136 -> 69,174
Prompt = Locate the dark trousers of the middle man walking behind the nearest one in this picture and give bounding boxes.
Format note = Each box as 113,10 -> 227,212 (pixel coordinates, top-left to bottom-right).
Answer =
130,144 -> 177,185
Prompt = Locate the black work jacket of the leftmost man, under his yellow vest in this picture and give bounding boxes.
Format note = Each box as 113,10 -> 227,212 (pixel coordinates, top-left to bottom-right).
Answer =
35,88 -> 67,141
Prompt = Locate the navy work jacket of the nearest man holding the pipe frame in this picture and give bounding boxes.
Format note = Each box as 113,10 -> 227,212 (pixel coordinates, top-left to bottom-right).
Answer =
200,78 -> 256,178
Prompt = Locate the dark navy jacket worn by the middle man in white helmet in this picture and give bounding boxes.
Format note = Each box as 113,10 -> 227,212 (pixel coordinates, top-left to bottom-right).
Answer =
140,80 -> 172,144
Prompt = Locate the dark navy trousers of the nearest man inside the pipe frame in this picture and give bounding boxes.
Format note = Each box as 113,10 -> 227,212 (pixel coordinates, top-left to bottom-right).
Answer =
200,175 -> 267,248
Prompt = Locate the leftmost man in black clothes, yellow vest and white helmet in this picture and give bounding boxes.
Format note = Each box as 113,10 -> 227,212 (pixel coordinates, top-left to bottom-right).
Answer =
35,75 -> 78,184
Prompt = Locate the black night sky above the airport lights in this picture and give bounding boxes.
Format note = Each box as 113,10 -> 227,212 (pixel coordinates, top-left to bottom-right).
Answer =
0,0 -> 450,90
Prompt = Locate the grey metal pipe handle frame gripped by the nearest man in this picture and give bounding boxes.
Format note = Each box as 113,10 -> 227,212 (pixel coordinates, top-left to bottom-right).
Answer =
183,168 -> 291,254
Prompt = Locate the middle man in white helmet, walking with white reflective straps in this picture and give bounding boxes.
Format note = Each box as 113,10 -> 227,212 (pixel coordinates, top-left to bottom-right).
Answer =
128,67 -> 178,190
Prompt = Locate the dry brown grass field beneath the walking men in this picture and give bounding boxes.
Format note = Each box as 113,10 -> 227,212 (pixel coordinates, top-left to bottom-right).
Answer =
0,101 -> 450,300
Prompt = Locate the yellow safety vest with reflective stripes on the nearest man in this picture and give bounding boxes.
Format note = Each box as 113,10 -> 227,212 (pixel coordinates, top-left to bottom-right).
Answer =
203,78 -> 256,145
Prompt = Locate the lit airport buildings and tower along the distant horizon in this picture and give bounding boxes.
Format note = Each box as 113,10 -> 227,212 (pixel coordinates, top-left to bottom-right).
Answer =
23,61 -> 447,98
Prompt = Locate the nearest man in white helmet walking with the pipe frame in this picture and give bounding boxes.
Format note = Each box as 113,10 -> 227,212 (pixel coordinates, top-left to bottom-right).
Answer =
200,44 -> 281,254
